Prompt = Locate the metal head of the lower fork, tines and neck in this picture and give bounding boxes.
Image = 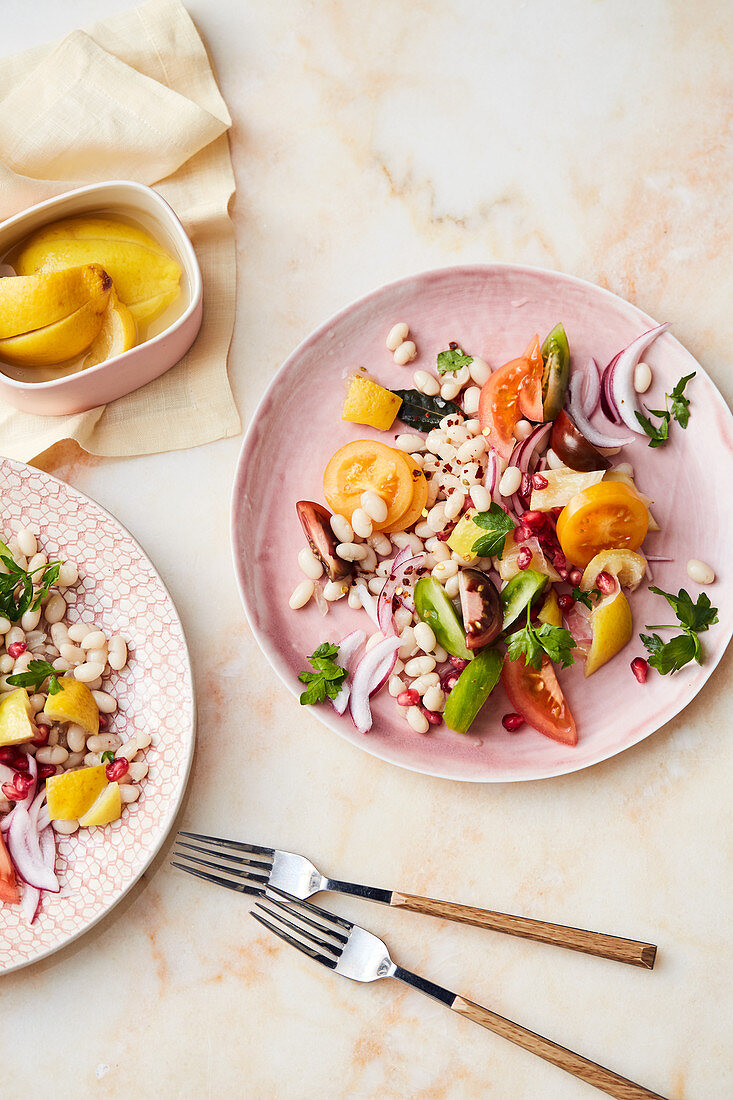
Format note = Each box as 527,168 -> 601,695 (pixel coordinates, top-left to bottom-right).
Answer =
252,886 -> 395,981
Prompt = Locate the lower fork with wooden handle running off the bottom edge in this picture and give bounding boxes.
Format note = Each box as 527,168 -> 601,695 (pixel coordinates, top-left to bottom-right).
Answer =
252,883 -> 664,1100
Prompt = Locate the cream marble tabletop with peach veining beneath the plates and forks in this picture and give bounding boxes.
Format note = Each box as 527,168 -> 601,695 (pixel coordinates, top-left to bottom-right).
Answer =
0,0 -> 733,1100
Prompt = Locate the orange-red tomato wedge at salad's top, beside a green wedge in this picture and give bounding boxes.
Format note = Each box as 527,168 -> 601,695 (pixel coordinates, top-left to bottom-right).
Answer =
479,336 -> 545,459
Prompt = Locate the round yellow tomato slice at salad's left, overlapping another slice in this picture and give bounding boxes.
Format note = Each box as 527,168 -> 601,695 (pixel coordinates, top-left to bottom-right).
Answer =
324,439 -> 415,531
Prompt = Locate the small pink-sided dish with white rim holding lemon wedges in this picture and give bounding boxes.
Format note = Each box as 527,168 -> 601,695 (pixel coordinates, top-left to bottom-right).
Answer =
0,179 -> 203,416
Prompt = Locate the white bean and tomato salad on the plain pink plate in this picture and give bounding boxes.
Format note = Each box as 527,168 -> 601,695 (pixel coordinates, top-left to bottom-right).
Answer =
289,322 -> 718,746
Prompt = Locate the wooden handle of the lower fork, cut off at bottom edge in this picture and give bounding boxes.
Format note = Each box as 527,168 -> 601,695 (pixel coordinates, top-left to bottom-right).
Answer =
450,997 -> 665,1100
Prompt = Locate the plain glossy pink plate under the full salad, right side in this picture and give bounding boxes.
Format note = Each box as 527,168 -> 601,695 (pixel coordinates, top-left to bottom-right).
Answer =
232,265 -> 733,782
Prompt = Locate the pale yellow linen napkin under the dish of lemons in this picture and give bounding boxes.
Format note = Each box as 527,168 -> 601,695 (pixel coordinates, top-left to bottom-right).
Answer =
0,0 -> 241,461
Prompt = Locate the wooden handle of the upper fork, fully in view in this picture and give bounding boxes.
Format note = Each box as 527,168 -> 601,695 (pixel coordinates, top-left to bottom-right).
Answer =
390,891 -> 657,972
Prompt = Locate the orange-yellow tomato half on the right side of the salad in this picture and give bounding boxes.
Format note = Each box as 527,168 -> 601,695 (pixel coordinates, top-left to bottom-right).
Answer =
557,482 -> 649,569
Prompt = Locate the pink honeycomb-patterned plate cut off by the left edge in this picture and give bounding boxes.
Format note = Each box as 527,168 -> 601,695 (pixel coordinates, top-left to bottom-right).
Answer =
0,459 -> 195,974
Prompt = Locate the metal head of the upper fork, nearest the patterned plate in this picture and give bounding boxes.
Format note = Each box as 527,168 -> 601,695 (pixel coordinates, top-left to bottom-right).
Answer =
173,833 -> 328,899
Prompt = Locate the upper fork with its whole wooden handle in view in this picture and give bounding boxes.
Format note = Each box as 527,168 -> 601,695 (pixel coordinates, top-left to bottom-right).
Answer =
172,832 -> 657,970
